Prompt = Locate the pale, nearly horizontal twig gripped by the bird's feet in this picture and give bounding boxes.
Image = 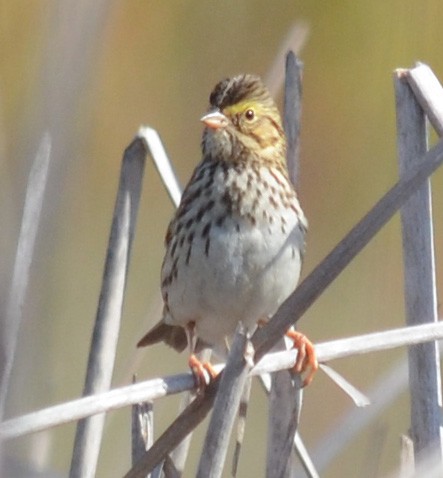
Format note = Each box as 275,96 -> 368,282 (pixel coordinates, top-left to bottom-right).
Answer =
0,322 -> 443,439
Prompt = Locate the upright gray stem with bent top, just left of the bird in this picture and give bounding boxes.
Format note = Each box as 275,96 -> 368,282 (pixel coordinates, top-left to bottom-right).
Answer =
70,137 -> 146,478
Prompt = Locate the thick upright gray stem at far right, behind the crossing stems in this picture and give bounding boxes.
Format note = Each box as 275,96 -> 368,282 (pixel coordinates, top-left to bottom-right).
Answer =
394,71 -> 443,461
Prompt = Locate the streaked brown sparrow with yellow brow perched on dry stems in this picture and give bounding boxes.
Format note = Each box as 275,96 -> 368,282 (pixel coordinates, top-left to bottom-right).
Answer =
137,74 -> 318,384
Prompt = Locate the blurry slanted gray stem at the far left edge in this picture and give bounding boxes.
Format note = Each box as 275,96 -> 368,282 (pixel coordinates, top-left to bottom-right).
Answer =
0,133 -> 51,420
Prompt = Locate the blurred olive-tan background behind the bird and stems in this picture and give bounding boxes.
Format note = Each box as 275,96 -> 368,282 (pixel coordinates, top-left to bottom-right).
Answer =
0,0 -> 443,478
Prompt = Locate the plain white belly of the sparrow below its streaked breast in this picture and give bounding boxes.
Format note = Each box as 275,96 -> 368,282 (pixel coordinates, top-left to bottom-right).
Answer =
166,210 -> 304,345
